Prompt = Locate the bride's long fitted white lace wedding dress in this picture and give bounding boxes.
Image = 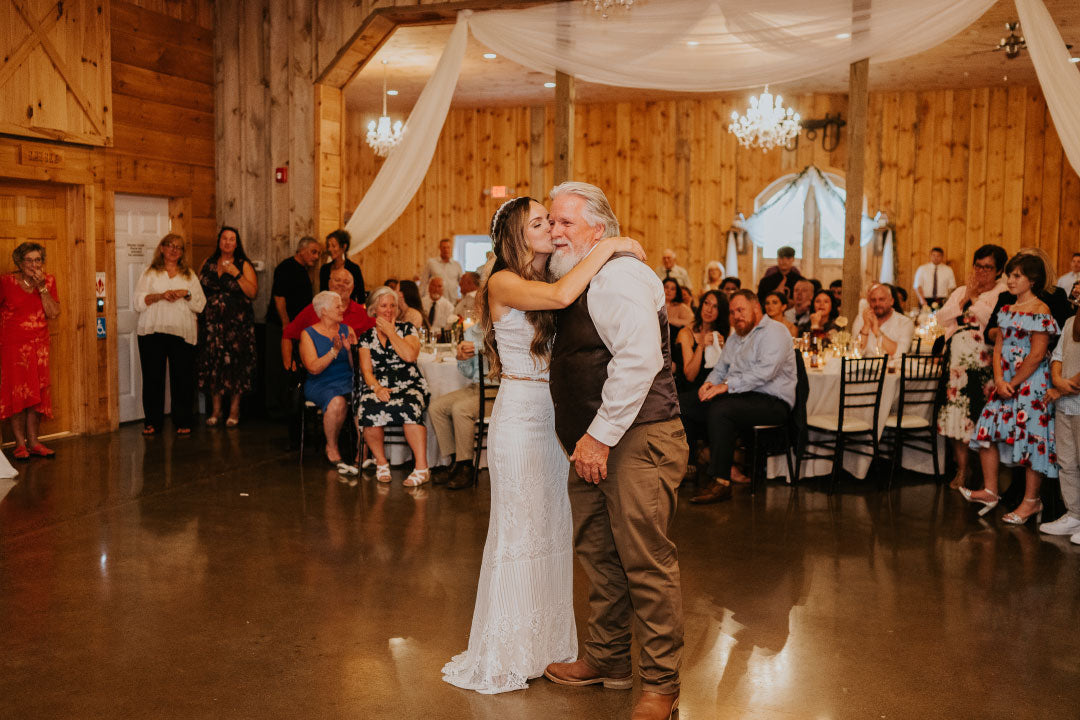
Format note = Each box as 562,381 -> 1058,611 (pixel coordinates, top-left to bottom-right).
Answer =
443,310 -> 578,694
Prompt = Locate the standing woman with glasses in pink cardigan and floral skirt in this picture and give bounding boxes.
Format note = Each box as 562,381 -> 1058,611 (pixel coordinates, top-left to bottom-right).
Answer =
937,245 -> 1009,490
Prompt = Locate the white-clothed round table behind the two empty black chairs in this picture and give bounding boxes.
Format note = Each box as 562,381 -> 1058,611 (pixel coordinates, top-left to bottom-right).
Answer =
768,358 -> 945,481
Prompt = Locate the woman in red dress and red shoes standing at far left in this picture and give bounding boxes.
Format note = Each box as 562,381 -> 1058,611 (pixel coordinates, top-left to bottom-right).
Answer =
0,243 -> 60,460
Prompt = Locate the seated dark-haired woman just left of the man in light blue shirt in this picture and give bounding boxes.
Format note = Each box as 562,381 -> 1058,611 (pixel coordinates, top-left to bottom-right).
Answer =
675,290 -> 731,477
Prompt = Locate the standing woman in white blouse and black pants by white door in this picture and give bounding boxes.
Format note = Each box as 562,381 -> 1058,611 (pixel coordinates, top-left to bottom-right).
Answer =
134,232 -> 206,435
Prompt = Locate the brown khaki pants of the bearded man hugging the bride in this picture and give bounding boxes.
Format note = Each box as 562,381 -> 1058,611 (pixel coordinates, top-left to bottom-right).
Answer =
568,419 -> 688,694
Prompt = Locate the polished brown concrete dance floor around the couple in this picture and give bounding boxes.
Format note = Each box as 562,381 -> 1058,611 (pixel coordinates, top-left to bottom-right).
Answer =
0,423 -> 1080,720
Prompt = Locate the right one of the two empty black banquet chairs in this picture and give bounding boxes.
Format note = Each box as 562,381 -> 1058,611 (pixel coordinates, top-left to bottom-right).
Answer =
881,354 -> 946,487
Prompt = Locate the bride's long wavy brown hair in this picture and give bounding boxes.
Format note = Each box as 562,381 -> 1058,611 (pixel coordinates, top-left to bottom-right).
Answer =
480,196 -> 555,378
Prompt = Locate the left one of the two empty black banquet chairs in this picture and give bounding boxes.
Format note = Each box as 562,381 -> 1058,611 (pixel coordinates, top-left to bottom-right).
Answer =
799,357 -> 888,492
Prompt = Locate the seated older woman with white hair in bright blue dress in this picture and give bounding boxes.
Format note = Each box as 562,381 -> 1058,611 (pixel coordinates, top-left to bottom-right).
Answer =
300,293 -> 356,463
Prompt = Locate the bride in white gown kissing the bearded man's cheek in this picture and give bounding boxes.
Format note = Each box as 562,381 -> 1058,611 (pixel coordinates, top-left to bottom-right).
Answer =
443,198 -> 645,694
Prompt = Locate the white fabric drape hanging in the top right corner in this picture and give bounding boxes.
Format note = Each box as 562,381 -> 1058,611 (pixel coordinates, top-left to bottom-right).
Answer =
1016,0 -> 1080,173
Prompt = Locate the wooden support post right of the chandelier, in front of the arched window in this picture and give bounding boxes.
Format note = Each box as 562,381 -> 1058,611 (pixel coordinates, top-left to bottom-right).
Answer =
840,59 -> 869,322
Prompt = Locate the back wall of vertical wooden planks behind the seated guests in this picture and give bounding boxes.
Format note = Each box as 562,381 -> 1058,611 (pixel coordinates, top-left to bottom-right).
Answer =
343,86 -> 1080,302
